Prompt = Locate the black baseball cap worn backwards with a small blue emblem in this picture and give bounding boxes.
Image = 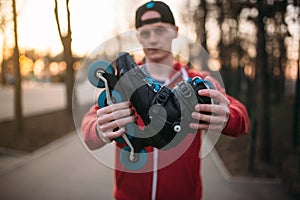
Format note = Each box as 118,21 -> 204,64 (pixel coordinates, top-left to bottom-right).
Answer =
135,1 -> 175,28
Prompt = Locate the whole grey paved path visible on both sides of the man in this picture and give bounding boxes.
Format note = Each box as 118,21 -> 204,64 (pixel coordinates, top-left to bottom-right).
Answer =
0,133 -> 290,200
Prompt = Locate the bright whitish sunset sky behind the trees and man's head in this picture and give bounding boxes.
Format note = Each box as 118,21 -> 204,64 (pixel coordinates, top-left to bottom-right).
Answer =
0,0 -> 198,55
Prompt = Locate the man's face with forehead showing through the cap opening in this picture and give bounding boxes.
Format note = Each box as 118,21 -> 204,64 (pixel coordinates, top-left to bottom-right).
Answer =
138,11 -> 178,62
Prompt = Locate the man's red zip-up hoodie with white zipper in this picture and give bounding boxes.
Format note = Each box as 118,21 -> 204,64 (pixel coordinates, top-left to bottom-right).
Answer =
82,63 -> 249,200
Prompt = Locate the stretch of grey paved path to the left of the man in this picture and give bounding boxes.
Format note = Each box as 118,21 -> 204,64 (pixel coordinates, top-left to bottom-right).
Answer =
0,133 -> 113,200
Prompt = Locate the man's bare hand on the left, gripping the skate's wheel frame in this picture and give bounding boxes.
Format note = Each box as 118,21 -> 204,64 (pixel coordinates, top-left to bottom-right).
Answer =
97,102 -> 137,141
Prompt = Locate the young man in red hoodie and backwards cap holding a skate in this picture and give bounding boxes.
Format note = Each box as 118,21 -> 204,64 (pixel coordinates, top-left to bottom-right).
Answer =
82,1 -> 249,200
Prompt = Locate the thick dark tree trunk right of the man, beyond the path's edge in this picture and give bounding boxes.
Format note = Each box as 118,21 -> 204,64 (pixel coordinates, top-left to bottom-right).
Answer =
256,1 -> 286,163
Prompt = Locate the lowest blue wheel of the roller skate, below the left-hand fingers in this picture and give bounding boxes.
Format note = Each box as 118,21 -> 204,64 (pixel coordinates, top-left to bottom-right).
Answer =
120,146 -> 147,170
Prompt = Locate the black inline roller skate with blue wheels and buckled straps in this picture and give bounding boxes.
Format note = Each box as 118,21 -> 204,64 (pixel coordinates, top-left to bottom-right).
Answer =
88,53 -> 213,170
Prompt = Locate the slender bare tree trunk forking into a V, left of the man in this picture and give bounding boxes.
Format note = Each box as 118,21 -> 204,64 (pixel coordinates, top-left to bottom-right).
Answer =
54,0 -> 76,113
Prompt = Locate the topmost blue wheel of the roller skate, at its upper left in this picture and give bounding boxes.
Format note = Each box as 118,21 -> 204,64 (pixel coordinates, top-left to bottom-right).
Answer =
88,60 -> 115,88
